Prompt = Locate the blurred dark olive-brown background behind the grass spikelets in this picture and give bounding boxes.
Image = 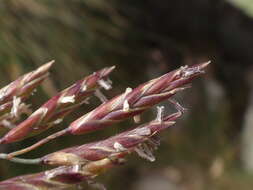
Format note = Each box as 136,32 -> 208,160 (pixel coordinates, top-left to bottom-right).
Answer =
0,0 -> 253,190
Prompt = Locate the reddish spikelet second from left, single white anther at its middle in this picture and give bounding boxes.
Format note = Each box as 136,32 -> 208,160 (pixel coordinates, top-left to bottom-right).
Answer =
1,67 -> 114,143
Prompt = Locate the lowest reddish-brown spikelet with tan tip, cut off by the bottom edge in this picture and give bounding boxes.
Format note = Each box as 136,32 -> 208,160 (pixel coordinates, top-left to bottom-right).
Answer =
0,159 -> 118,190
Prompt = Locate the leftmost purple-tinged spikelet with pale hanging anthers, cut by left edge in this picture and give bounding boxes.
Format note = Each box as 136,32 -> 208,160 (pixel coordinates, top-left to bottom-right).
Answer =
0,61 -> 54,129
